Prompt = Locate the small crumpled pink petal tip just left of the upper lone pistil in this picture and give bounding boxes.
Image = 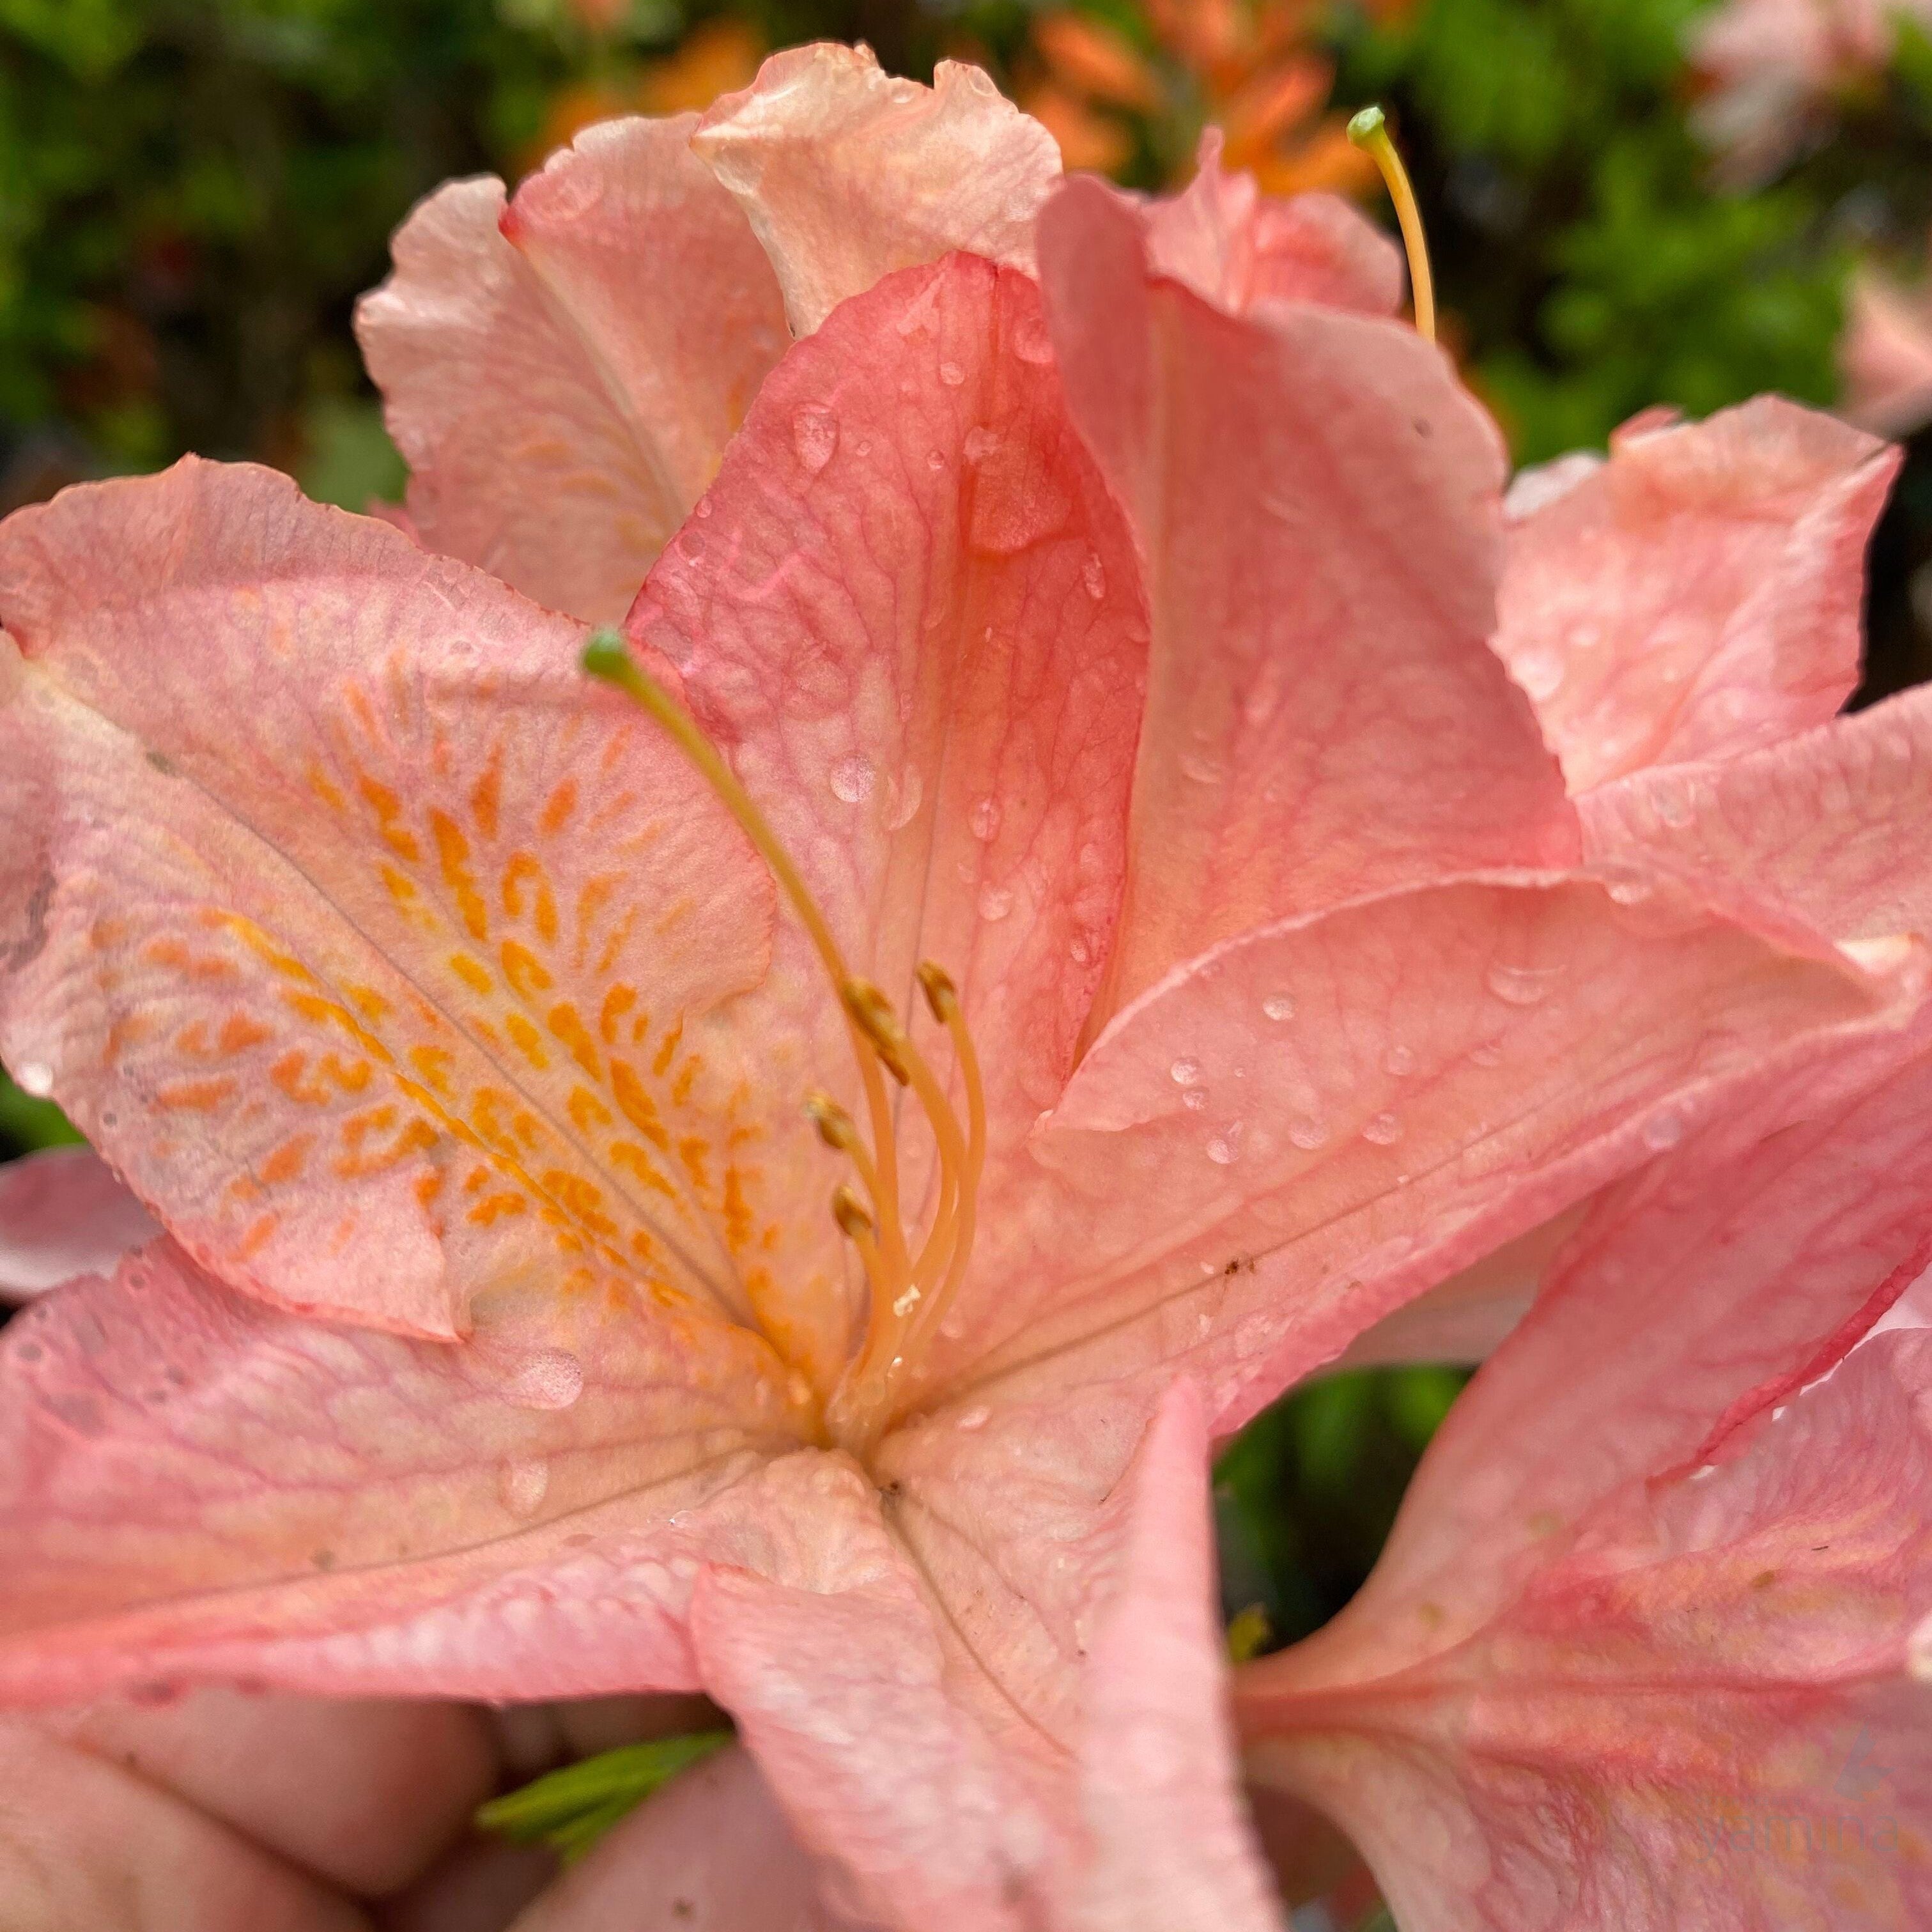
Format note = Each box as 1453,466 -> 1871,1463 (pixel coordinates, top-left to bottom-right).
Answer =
1128,128 -> 1405,315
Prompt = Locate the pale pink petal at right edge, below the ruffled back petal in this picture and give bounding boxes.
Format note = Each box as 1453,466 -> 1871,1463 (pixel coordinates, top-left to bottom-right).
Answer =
1584,688 -> 1932,941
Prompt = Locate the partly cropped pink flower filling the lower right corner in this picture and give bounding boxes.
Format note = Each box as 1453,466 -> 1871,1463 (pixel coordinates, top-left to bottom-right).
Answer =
1240,1028 -> 1932,1932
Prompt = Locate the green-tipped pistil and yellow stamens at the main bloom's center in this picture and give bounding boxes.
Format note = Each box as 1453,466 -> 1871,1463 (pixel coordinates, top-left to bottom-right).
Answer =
583,630 -> 985,1457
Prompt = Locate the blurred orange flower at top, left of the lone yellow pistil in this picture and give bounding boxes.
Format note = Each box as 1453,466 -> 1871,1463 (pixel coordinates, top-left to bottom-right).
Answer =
1022,0 -> 1410,195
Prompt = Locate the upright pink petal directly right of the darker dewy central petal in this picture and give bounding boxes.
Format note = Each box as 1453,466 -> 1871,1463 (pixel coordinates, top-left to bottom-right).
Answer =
1041,182 -> 1577,1003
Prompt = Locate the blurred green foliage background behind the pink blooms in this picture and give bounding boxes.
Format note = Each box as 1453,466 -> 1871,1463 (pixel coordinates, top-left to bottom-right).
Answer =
0,0 -> 1932,1692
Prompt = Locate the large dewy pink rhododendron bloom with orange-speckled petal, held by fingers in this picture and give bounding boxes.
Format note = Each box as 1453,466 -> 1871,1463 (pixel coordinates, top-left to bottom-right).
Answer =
0,37 -> 1922,1932
